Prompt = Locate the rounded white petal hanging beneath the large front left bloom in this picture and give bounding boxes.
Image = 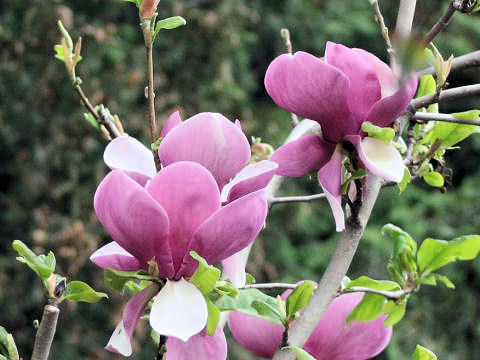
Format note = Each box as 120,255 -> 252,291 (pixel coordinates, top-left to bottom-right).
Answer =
150,278 -> 208,341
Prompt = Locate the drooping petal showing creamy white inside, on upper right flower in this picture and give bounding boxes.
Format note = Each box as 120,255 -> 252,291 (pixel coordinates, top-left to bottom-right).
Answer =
346,135 -> 405,183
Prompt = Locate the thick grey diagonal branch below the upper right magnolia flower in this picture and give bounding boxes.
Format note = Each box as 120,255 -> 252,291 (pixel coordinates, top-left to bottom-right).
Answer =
274,176 -> 381,360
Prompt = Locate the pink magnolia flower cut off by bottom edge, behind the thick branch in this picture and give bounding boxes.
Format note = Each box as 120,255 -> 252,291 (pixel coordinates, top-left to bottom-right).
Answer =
228,292 -> 392,360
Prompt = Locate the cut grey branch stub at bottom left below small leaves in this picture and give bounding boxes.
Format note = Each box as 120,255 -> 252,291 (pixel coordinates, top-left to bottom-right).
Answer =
32,305 -> 60,360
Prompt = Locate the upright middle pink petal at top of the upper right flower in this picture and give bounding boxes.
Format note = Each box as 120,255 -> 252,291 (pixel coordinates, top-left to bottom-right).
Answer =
325,42 -> 382,124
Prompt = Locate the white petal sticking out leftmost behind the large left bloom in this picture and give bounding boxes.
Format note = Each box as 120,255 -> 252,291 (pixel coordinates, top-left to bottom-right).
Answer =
103,136 -> 157,177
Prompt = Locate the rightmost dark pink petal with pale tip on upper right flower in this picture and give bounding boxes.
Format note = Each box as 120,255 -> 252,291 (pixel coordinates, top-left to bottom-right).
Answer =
366,75 -> 418,127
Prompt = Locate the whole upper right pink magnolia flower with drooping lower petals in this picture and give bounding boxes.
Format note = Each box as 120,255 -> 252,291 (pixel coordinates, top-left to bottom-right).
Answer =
265,42 -> 417,231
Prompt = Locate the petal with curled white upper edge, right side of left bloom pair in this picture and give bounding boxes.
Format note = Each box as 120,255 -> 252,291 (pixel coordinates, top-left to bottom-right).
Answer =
221,160 -> 278,202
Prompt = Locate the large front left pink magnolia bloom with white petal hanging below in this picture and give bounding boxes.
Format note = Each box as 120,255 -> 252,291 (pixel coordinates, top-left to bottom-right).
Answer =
91,161 -> 267,360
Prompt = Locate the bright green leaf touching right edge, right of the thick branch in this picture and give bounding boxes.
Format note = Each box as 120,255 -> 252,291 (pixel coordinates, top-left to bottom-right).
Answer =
417,235 -> 480,275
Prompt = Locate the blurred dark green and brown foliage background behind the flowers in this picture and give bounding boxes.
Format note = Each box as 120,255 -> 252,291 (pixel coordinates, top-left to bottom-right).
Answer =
0,0 -> 480,360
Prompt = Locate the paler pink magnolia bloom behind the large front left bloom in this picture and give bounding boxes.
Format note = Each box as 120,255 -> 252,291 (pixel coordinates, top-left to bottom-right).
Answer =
104,111 -> 278,287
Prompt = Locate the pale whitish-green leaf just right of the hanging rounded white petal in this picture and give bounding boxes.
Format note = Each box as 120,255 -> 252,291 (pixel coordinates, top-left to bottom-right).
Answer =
217,289 -> 283,324
